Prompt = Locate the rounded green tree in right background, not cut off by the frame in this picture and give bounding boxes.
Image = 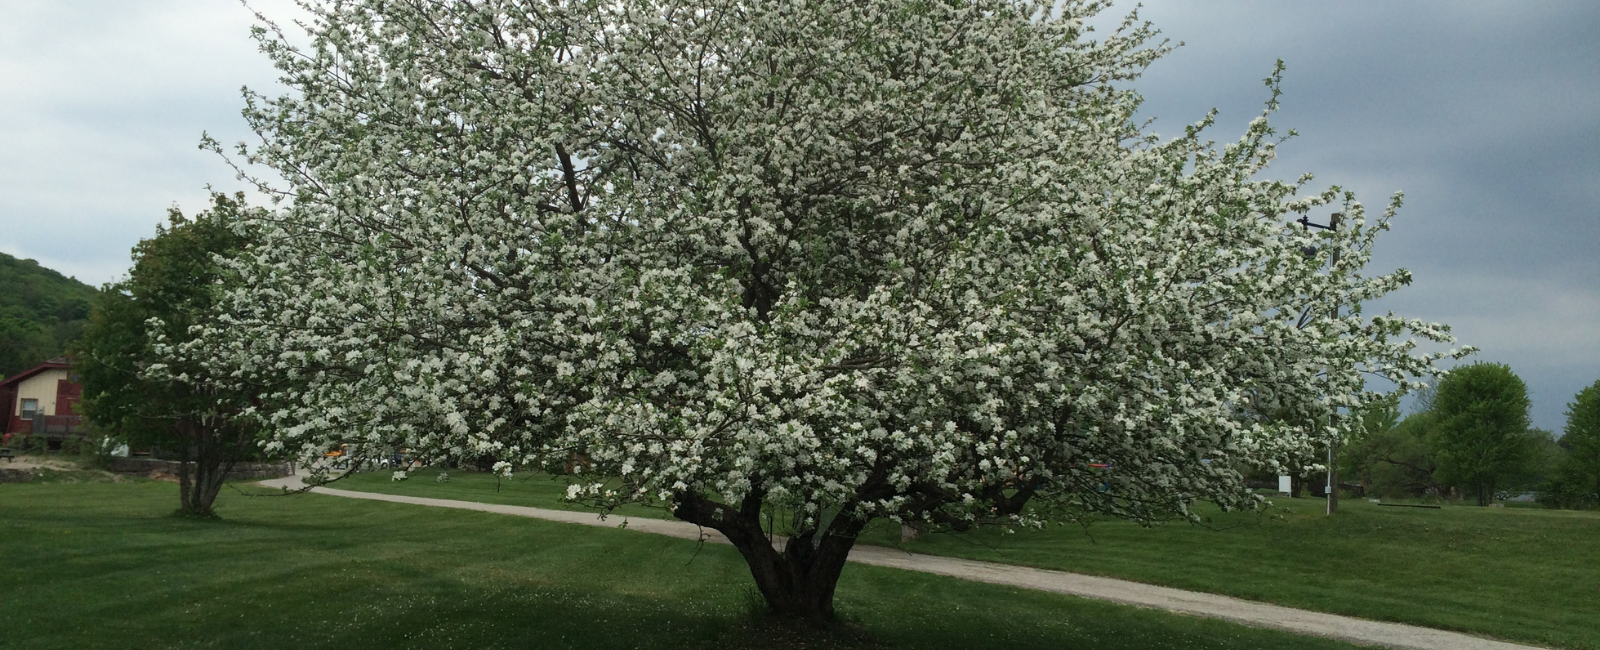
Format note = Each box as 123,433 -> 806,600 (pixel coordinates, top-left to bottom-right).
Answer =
1427,363 -> 1538,506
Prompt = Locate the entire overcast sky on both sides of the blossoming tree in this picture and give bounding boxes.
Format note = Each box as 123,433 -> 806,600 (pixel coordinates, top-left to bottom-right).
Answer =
0,0 -> 1600,432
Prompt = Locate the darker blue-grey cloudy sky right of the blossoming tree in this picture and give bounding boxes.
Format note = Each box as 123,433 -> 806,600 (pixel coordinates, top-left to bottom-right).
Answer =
1114,2 -> 1600,431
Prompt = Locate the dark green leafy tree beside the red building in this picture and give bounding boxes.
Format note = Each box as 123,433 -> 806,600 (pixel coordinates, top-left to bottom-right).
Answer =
74,194 -> 258,517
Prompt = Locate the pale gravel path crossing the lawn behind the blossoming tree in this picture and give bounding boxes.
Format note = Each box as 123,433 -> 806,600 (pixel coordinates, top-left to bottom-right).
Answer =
261,477 -> 1538,650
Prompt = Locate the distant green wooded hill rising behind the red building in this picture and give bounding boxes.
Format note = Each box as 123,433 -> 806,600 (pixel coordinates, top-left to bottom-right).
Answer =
0,253 -> 99,376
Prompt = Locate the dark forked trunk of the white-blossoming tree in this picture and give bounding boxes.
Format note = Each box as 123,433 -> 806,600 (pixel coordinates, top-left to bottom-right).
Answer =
674,495 -> 866,624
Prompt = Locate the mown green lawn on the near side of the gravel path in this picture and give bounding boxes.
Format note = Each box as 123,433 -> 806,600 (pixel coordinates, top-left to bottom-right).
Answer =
0,482 -> 1376,650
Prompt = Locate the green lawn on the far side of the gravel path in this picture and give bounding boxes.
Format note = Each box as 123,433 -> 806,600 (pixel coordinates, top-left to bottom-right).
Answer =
336,471 -> 1600,650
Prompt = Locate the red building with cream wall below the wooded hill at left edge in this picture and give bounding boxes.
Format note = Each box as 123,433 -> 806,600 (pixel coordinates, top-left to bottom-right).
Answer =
0,357 -> 83,447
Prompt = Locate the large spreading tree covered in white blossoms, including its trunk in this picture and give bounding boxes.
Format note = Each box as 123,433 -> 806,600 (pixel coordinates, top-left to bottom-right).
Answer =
196,0 -> 1448,618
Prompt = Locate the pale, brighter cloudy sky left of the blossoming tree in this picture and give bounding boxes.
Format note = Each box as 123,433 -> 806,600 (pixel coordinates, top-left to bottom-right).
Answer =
0,0 -> 297,283
